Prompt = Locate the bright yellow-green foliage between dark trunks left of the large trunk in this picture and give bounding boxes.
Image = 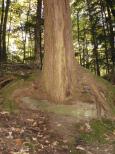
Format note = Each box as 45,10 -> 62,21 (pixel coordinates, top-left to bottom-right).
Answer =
6,0 -> 37,62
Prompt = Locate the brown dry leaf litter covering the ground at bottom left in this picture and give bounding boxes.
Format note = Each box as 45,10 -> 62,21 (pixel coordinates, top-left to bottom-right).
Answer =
0,110 -> 69,154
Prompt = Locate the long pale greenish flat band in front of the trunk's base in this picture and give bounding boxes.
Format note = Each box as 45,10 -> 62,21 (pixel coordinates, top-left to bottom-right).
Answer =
21,97 -> 97,119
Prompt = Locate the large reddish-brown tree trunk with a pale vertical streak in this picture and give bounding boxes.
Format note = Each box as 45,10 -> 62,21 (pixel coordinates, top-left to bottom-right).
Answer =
43,0 -> 75,103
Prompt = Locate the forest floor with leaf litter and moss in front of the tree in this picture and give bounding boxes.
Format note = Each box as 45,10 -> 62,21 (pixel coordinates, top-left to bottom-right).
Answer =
0,71 -> 115,154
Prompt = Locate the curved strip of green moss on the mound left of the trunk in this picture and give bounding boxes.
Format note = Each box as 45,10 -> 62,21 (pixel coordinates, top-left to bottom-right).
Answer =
0,73 -> 38,112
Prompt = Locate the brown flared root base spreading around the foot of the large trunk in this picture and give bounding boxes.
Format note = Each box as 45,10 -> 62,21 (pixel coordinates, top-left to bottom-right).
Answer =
13,65 -> 114,118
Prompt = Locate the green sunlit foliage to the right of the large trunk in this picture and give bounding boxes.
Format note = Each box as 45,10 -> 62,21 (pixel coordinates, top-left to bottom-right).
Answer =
71,0 -> 114,75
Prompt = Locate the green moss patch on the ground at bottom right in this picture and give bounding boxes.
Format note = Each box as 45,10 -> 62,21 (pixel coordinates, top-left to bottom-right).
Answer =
80,119 -> 115,144
